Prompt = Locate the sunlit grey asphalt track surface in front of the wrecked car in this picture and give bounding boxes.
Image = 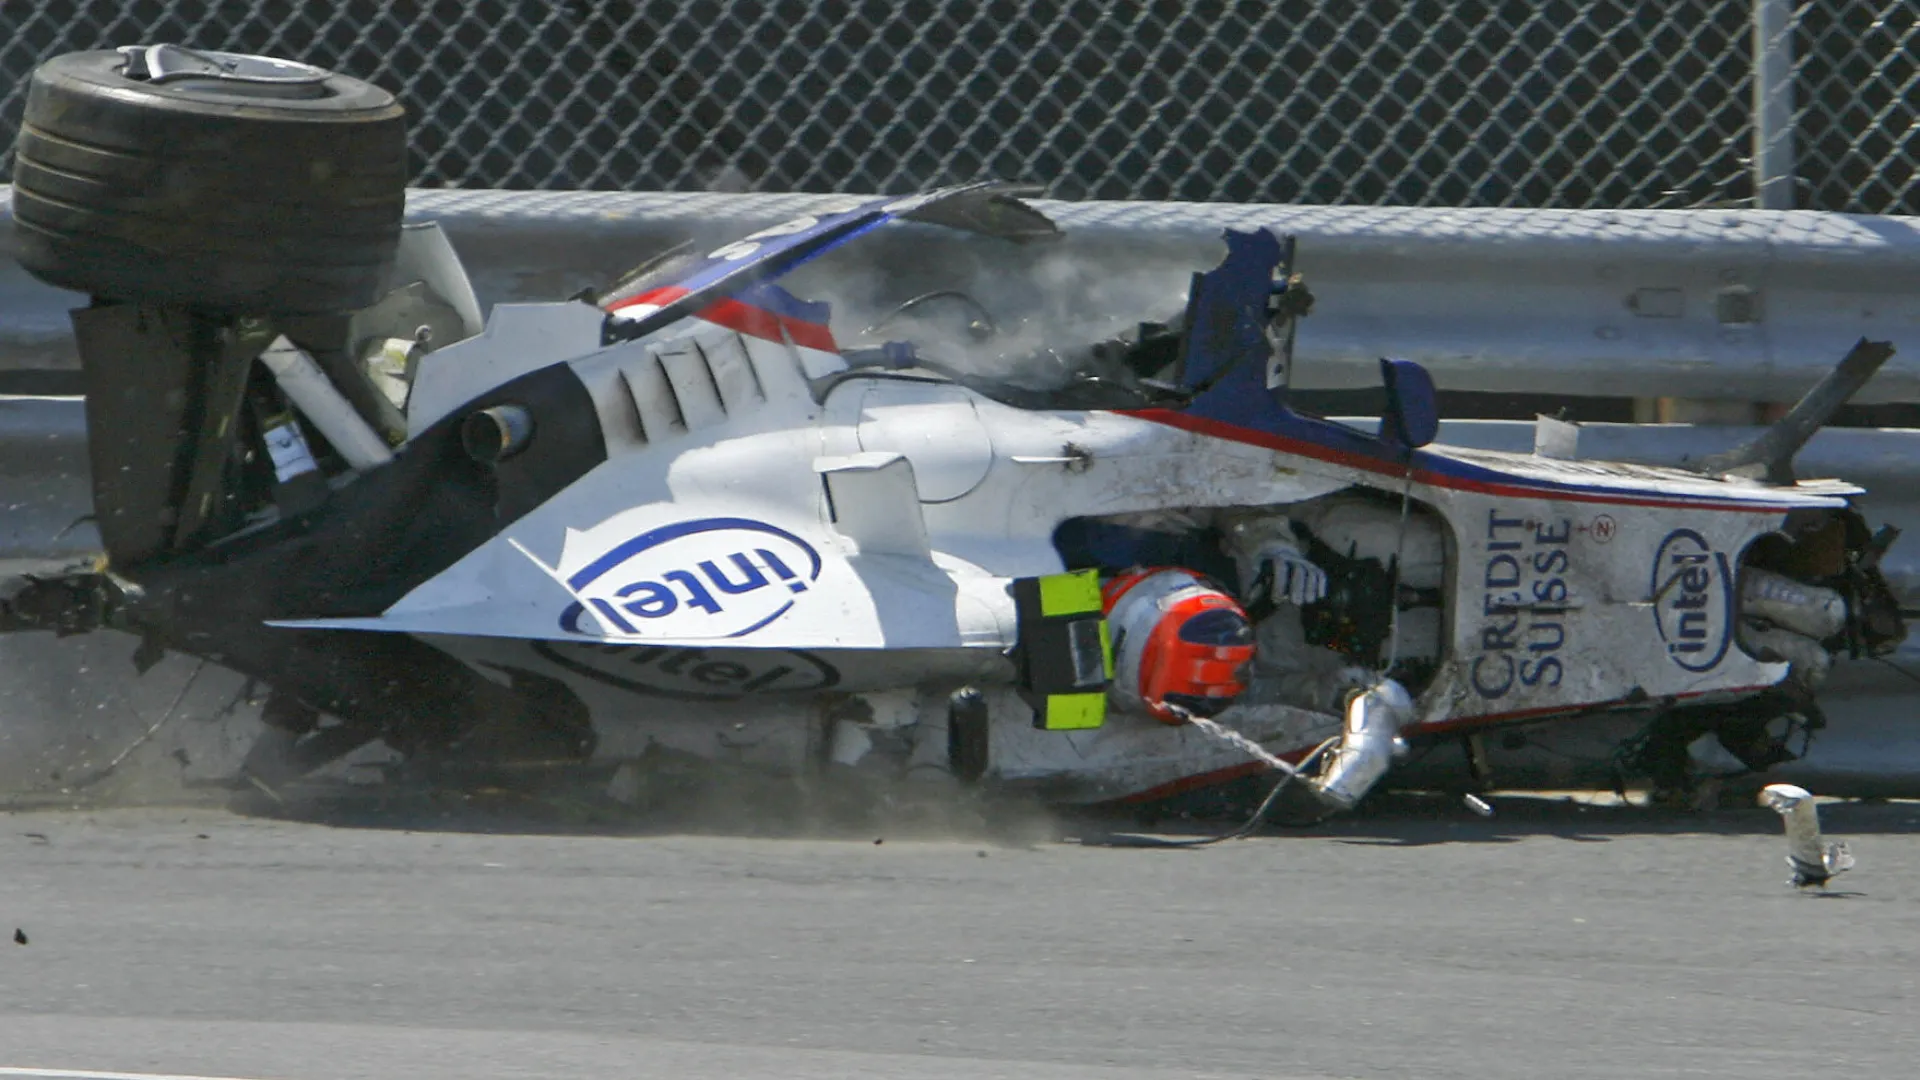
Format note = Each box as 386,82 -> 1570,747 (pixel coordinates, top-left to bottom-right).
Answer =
0,799 -> 1920,1080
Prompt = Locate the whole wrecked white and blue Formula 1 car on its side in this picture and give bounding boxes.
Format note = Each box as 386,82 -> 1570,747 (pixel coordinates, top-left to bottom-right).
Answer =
6,46 -> 1905,809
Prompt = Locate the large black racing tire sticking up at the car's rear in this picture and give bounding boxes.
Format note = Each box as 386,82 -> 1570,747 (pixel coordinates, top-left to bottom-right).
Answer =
13,52 -> 407,315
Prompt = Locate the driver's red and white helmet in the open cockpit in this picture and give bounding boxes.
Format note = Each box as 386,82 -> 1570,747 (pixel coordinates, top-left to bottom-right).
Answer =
1100,567 -> 1254,724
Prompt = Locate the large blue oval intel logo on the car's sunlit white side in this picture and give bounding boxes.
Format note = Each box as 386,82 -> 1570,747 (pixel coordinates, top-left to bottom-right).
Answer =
561,517 -> 820,638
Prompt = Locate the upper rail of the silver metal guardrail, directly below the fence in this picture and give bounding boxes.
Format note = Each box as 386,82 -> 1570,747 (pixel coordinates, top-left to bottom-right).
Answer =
11,188 -> 1920,402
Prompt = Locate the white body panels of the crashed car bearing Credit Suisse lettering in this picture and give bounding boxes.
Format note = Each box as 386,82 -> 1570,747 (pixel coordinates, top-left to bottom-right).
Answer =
274,270 -> 1851,799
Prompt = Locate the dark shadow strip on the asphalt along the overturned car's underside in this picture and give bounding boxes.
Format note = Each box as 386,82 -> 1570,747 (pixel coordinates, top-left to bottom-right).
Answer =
214,780 -> 1920,847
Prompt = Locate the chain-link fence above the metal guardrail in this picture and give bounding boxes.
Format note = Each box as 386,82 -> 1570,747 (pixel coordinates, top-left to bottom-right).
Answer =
0,0 -> 1920,213
